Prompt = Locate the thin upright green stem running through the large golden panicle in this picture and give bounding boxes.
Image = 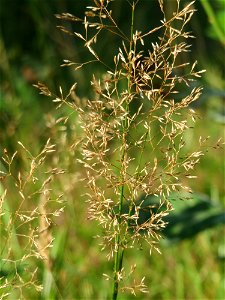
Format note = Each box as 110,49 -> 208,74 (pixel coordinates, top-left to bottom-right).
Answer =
112,1 -> 135,300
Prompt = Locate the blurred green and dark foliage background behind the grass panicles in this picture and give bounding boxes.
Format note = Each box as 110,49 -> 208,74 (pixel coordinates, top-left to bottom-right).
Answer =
0,0 -> 225,299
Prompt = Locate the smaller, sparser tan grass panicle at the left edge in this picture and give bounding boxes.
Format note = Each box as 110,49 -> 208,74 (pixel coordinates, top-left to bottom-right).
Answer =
0,140 -> 64,299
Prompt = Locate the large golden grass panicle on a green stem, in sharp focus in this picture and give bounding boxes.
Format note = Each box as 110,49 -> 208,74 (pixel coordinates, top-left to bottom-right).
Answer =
36,0 -> 224,299
